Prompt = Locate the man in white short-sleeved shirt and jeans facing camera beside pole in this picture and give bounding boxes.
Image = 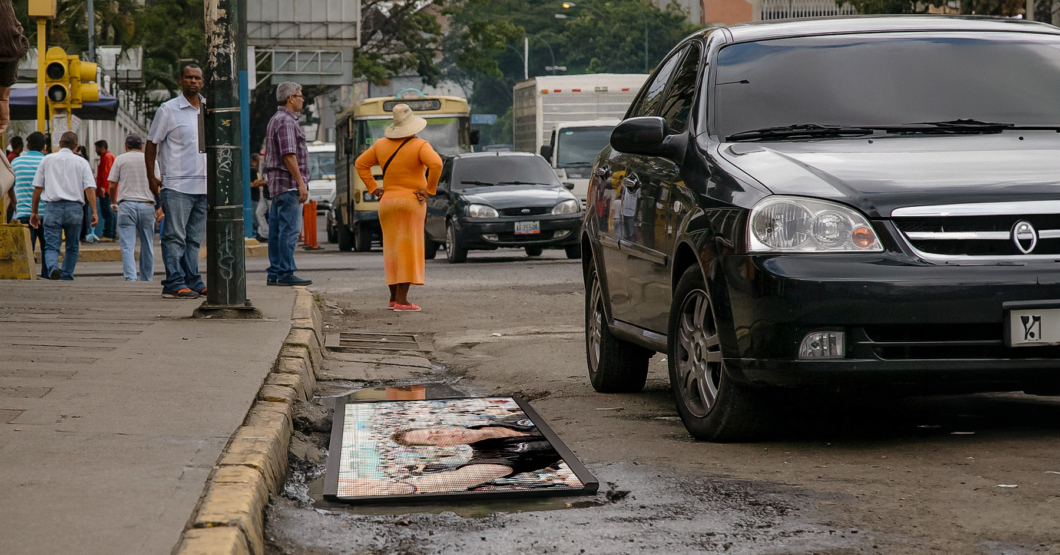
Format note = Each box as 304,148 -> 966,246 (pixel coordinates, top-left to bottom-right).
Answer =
144,65 -> 207,299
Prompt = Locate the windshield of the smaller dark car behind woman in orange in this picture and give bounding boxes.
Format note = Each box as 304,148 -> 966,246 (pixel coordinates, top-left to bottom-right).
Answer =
451,156 -> 560,190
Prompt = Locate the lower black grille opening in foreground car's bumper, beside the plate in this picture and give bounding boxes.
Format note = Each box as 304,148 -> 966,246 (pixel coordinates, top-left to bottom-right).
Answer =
851,323 -> 1060,360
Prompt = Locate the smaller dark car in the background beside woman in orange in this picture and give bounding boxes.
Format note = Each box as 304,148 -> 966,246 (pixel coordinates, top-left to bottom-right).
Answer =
424,153 -> 582,263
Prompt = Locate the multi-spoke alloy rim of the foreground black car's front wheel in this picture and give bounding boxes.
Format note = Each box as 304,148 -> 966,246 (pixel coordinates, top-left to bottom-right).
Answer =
675,289 -> 722,418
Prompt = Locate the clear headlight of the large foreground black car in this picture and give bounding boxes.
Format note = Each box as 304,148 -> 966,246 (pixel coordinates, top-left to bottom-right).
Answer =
747,196 -> 883,252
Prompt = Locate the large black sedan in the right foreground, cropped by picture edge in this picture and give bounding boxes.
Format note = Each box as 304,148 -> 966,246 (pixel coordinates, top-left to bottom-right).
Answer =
582,17 -> 1060,441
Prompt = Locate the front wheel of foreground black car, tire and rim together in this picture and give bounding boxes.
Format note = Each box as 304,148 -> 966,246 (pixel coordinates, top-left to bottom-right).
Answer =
667,265 -> 769,443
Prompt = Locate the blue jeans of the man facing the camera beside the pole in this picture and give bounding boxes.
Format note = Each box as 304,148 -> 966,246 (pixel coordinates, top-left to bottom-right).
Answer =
157,189 -> 206,293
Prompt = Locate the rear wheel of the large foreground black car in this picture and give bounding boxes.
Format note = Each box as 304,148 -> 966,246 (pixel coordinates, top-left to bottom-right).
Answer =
585,264 -> 654,393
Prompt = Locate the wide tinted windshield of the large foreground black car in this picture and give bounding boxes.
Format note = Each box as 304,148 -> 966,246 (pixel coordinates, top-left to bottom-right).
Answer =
713,33 -> 1060,138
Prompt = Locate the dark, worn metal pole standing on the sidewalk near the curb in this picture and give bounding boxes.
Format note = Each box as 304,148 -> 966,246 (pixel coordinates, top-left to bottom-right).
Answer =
195,0 -> 261,318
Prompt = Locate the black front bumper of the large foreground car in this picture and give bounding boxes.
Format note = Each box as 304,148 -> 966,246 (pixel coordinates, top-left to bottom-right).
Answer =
716,254 -> 1060,386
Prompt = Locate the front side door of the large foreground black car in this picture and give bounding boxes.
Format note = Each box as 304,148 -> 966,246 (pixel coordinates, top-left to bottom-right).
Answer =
619,47 -> 699,334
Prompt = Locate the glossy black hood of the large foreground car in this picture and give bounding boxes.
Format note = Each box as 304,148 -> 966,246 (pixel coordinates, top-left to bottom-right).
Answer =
719,131 -> 1060,218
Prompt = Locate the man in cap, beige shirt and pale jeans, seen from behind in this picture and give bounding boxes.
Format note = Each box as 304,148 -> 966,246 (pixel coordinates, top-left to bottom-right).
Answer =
107,133 -> 161,282
